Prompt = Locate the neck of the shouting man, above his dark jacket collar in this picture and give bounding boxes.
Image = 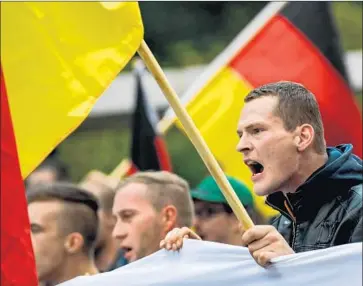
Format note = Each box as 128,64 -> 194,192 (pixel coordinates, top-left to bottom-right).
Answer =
282,153 -> 328,194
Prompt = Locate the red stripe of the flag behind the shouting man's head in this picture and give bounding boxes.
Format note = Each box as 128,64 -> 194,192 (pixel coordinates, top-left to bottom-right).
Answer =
230,16 -> 362,157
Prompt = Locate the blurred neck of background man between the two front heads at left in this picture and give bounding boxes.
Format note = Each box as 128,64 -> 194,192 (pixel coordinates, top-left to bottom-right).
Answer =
96,237 -> 119,272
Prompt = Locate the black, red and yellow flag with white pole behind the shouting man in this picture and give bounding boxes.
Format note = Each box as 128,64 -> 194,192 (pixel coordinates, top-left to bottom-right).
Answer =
161,2 -> 362,219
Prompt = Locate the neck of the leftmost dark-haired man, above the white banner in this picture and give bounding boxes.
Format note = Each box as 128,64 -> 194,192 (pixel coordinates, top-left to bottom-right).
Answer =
50,255 -> 99,285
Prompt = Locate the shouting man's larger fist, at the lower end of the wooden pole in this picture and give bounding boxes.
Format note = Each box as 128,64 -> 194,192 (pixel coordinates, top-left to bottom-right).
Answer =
242,225 -> 294,266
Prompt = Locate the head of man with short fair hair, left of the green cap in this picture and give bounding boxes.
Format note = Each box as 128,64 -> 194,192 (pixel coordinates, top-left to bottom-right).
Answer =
113,171 -> 194,262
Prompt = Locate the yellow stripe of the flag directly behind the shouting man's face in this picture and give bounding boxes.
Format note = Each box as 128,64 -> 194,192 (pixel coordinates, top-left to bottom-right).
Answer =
176,66 -> 277,217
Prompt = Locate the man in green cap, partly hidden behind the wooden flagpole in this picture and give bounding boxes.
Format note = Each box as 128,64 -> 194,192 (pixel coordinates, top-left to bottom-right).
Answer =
191,176 -> 262,245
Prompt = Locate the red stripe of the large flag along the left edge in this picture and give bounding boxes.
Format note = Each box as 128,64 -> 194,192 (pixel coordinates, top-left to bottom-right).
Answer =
0,67 -> 38,286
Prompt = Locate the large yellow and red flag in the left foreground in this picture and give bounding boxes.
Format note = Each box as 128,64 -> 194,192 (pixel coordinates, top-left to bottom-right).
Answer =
1,2 -> 143,286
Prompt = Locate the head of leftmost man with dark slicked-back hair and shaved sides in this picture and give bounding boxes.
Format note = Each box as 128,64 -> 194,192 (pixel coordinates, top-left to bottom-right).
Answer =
27,183 -> 98,285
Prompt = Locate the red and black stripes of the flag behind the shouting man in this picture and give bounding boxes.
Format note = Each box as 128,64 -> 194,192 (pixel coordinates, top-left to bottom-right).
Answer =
230,2 -> 362,156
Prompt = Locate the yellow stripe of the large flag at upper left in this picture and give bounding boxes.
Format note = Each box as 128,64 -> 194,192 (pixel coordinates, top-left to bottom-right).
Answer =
1,2 -> 144,178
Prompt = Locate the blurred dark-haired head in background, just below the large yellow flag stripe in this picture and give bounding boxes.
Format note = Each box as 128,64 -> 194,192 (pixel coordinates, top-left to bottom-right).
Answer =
25,157 -> 70,188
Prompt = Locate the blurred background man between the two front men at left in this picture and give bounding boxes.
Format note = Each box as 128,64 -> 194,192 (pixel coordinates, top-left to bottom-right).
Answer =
79,171 -> 127,272
